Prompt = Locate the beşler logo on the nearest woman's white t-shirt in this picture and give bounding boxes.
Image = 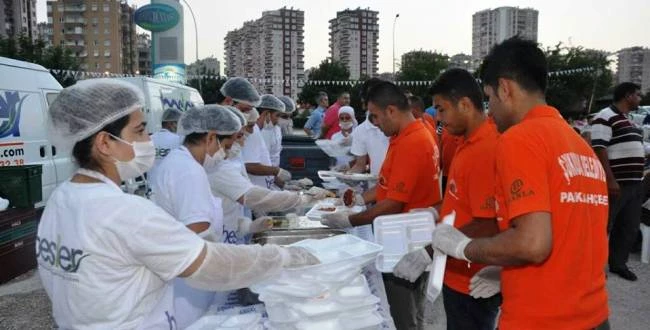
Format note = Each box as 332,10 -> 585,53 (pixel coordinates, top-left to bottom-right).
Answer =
36,235 -> 89,273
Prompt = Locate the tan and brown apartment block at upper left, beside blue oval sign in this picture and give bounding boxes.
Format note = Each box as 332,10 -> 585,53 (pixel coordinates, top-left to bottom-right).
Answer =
47,0 -> 137,73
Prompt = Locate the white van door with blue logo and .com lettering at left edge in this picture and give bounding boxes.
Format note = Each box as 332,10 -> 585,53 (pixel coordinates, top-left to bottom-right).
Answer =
0,89 -> 57,202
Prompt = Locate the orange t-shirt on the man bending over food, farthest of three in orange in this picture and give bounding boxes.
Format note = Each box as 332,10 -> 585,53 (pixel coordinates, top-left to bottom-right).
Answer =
377,120 -> 441,212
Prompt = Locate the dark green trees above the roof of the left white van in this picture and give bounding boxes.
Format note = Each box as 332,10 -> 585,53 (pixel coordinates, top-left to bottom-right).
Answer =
0,35 -> 80,87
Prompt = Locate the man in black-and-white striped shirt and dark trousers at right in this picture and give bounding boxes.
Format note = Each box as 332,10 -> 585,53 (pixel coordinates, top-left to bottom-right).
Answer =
591,82 -> 645,281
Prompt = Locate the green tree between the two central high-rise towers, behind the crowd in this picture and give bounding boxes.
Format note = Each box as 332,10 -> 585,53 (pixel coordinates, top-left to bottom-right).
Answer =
298,59 -> 352,104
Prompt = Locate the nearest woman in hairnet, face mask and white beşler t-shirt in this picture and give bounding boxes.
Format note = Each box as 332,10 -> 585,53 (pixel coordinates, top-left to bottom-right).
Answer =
36,79 -> 317,329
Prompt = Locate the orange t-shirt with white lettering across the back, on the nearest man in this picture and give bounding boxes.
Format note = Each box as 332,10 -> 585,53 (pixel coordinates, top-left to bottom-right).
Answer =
495,106 -> 609,330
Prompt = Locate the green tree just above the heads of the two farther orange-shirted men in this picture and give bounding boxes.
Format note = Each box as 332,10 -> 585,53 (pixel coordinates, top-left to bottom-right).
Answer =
397,50 -> 449,106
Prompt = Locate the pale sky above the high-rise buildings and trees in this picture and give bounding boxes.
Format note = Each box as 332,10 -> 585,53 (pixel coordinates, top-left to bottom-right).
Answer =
37,0 -> 650,72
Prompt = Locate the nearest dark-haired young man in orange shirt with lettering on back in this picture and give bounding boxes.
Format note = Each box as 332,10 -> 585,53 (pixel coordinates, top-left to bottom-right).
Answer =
432,37 -> 609,330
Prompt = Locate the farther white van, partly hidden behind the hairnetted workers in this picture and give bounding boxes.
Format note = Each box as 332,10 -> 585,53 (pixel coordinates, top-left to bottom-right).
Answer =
115,77 -> 203,134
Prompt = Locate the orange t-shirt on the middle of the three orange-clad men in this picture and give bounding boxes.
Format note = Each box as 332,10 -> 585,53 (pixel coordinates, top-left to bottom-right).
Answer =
440,121 -> 499,294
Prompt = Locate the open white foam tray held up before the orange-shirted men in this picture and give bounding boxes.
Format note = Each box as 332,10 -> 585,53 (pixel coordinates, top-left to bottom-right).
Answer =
373,212 -> 435,273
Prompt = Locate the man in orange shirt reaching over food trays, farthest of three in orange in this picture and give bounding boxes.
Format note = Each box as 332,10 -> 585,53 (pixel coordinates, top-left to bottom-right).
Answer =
321,82 -> 441,329
